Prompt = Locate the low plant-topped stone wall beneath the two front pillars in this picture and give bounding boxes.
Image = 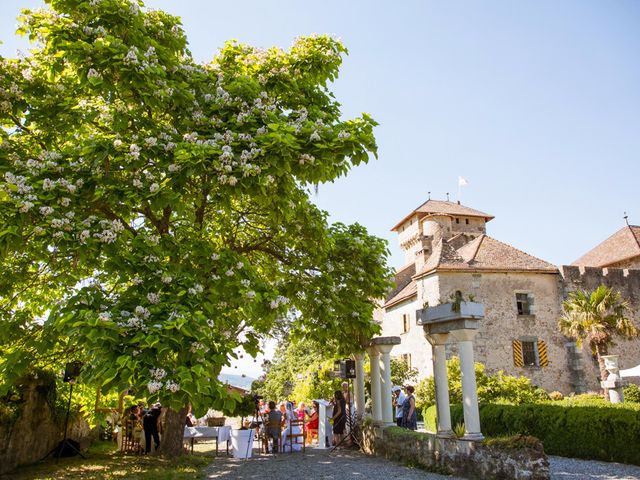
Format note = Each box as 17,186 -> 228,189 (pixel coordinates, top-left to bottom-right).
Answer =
363,425 -> 550,480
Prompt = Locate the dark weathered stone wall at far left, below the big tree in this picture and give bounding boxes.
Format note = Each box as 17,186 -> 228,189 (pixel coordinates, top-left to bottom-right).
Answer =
0,379 -> 91,474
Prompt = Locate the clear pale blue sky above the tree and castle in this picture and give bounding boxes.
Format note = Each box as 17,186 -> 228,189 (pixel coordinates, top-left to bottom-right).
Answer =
0,0 -> 640,376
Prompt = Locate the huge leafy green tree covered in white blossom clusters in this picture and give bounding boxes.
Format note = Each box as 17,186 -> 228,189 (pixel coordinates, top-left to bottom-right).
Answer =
0,0 -> 389,451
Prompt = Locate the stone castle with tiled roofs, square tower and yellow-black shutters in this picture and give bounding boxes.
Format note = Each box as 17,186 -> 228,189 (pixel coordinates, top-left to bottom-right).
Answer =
378,199 -> 640,394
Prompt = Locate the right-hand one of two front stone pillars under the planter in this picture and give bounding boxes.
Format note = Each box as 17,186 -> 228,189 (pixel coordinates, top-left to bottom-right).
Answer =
451,329 -> 484,440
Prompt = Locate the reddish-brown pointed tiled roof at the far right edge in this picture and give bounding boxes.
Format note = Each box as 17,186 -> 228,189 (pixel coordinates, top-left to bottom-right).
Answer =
572,225 -> 640,267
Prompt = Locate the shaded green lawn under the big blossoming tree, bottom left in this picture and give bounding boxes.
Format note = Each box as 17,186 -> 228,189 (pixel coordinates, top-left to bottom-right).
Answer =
0,442 -> 212,480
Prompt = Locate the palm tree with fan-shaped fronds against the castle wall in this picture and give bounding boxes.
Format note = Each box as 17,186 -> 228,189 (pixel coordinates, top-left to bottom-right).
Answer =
558,285 -> 638,393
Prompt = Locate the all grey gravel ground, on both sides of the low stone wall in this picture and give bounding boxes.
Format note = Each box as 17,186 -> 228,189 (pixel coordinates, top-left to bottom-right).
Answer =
205,449 -> 640,480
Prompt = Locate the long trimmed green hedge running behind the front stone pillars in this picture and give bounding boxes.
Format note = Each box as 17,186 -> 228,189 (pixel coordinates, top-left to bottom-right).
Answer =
451,399 -> 640,465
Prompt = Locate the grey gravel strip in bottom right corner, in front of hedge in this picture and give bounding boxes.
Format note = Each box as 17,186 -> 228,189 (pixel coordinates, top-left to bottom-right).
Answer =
549,455 -> 640,480
